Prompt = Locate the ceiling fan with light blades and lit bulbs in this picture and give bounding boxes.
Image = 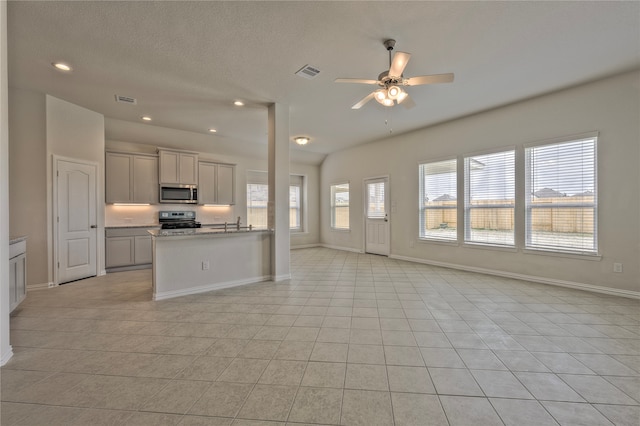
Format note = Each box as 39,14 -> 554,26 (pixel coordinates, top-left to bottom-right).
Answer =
335,40 -> 453,109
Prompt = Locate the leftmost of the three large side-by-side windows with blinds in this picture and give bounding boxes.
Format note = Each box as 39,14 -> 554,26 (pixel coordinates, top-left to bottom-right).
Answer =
419,158 -> 458,241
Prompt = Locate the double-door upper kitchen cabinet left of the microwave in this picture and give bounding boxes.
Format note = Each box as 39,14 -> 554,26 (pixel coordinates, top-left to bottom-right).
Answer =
105,152 -> 159,204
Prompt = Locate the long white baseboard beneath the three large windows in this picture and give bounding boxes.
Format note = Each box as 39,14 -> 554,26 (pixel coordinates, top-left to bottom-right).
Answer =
389,255 -> 640,299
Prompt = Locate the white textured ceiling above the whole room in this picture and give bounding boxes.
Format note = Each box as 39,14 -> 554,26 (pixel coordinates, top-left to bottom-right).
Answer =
8,1 -> 640,163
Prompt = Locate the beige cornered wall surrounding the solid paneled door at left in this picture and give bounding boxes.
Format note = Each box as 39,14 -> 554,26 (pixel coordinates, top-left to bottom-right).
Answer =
9,92 -> 104,288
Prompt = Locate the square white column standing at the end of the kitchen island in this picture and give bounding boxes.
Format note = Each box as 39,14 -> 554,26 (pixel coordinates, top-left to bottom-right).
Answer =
268,103 -> 291,281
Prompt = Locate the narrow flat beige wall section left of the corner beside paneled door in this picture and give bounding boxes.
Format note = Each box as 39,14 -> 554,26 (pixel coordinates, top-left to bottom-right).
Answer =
9,88 -> 49,286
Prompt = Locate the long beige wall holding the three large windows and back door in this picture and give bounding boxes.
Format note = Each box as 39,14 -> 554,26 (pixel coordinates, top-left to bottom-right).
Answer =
320,72 -> 640,293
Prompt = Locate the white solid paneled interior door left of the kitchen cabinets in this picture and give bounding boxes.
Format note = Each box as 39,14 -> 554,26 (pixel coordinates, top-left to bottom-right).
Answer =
56,159 -> 98,284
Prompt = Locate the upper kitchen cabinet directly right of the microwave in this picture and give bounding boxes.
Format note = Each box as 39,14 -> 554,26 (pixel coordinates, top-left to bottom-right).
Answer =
198,162 -> 236,205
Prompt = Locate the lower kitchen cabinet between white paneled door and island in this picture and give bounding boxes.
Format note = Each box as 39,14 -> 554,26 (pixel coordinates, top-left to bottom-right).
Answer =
105,228 -> 156,272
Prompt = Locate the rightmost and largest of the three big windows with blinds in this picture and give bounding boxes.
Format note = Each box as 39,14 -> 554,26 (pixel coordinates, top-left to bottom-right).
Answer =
525,136 -> 598,254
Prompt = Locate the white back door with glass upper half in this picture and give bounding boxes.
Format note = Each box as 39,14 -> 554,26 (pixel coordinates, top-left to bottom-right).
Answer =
364,178 -> 391,256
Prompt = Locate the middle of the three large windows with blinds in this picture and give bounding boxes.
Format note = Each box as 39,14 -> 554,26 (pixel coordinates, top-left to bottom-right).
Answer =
464,150 -> 515,246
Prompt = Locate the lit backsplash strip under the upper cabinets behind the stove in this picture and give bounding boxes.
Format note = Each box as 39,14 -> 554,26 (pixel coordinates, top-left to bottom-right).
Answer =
104,204 -> 238,227
